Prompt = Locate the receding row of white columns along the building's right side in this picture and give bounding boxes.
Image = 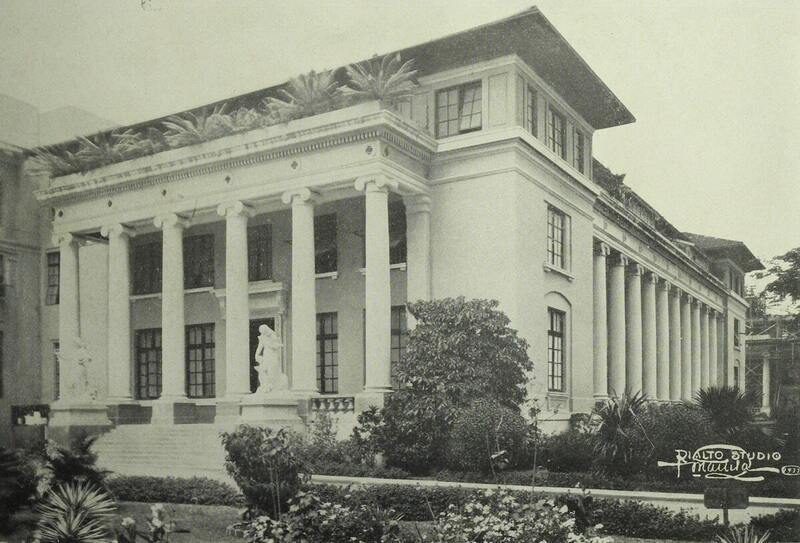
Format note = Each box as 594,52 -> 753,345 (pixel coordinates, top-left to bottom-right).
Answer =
593,243 -> 724,400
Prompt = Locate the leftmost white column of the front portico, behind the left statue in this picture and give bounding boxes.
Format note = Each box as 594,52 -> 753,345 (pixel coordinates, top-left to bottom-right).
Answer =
53,234 -> 81,401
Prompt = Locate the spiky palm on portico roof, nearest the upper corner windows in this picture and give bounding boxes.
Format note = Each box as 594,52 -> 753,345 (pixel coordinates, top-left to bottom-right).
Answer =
344,53 -> 418,105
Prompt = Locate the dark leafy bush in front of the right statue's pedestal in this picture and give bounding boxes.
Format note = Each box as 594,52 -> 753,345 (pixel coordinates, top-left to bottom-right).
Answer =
222,425 -> 306,518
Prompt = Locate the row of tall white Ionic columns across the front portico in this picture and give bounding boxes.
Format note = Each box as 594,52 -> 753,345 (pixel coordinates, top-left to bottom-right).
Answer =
58,176 -> 430,410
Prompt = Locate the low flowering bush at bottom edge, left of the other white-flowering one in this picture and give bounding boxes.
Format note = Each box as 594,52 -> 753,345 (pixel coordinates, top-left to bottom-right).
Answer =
246,492 -> 400,543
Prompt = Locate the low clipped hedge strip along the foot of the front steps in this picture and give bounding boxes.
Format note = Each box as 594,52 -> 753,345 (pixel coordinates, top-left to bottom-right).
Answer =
106,476 -> 241,505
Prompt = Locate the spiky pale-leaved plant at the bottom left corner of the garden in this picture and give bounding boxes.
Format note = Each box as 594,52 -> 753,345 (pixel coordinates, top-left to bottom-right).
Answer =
36,481 -> 116,543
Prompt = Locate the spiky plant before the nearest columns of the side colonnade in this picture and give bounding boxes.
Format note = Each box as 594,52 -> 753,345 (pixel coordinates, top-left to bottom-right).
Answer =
594,390 -> 647,471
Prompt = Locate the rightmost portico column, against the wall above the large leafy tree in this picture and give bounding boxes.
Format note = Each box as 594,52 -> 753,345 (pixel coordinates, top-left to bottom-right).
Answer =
404,194 -> 431,328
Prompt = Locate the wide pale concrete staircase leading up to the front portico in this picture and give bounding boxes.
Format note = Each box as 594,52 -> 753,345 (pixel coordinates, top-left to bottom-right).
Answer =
93,424 -> 232,483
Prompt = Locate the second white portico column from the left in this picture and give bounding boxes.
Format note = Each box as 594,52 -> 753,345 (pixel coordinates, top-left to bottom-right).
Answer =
100,224 -> 134,403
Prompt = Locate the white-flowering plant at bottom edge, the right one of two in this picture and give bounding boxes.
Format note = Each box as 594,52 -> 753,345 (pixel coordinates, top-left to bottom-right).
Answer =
431,490 -> 612,543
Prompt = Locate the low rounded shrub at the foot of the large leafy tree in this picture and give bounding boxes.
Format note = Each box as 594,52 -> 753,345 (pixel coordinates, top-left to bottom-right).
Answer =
446,400 -> 528,473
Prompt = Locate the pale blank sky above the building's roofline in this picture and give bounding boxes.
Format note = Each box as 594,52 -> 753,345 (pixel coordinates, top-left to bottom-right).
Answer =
0,0 -> 800,257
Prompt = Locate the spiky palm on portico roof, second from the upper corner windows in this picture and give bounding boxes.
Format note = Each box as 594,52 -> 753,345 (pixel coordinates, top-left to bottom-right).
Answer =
264,70 -> 342,122
